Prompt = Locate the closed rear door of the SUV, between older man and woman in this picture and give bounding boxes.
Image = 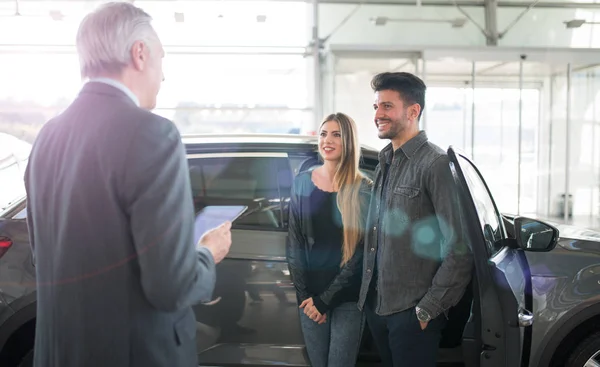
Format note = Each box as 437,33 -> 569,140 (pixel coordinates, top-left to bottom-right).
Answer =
188,152 -> 308,365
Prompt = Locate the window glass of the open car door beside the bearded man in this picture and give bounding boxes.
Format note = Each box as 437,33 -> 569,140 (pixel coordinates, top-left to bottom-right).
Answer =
458,156 -> 504,256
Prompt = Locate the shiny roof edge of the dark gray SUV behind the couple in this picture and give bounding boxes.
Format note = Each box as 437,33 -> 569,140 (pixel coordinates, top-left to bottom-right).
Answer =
181,134 -> 378,157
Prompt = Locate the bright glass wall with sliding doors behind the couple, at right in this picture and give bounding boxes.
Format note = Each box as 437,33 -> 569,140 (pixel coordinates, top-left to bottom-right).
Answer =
332,52 -> 600,227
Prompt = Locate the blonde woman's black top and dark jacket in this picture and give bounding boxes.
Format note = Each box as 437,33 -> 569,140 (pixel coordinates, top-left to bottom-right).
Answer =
286,171 -> 371,313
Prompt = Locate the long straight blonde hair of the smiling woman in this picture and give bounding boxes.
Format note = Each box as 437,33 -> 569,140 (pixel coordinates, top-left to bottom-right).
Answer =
320,112 -> 365,266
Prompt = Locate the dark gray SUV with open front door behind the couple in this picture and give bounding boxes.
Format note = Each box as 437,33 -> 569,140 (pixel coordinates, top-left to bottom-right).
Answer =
0,135 -> 600,367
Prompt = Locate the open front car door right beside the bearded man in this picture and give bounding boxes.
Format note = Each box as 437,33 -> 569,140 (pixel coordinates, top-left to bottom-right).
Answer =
448,147 -> 533,367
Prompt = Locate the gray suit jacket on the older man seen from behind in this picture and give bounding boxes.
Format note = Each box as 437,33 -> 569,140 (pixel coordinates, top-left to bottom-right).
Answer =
25,82 -> 216,367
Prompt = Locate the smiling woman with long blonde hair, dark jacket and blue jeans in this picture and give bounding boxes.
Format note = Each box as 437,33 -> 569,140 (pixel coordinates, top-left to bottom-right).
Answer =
286,113 -> 371,367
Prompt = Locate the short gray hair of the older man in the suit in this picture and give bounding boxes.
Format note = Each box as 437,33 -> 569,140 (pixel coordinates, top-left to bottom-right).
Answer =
76,2 -> 158,78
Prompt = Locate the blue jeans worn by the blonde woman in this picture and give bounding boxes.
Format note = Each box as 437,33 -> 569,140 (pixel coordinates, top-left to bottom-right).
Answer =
300,302 -> 365,367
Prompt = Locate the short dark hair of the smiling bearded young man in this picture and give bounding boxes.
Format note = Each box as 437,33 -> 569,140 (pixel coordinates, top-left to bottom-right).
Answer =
371,72 -> 427,119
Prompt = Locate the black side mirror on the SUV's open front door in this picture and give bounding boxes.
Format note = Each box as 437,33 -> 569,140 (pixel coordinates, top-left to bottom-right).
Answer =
514,217 -> 559,252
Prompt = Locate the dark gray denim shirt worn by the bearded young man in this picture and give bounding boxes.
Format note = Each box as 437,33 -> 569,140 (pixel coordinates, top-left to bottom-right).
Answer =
358,131 -> 473,318
